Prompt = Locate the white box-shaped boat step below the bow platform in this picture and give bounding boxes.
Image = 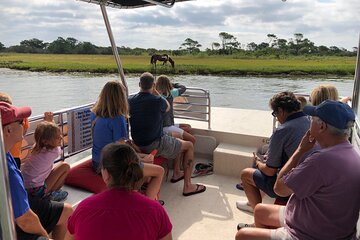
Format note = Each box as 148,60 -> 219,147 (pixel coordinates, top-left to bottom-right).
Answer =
213,143 -> 257,177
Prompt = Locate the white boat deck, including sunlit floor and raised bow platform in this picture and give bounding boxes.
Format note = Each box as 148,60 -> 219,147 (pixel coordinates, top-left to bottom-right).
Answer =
64,108 -> 273,240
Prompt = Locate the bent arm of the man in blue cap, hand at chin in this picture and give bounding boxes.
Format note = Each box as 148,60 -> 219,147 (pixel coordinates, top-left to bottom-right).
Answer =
274,130 -> 316,197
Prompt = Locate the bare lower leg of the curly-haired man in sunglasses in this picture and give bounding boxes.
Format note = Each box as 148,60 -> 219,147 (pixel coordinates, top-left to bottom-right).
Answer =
240,168 -> 262,209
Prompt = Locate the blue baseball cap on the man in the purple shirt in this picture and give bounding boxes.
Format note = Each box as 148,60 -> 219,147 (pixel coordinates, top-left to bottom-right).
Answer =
303,100 -> 355,129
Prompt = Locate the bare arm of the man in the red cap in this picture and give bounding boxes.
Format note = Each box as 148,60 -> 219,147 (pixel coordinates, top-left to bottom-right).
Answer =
15,209 -> 49,238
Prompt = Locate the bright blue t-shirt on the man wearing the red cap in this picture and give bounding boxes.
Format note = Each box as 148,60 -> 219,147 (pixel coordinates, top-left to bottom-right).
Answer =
6,153 -> 30,219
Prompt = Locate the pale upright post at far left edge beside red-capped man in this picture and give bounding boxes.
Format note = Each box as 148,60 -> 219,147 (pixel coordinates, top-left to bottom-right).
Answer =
0,113 -> 16,240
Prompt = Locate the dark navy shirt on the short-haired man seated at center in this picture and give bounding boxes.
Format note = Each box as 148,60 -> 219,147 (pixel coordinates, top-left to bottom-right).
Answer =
129,92 -> 167,146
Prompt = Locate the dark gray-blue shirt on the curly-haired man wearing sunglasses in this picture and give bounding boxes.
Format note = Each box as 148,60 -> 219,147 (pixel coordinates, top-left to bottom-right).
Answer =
266,112 -> 310,169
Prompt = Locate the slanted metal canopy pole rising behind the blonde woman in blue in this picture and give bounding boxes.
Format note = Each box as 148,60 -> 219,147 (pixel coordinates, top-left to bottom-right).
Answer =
100,3 -> 129,96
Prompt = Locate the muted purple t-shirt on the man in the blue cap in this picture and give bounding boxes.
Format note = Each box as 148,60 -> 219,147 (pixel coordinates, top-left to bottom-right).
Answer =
283,142 -> 360,240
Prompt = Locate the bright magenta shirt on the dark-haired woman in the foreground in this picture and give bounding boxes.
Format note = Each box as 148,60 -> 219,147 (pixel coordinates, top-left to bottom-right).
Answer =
68,188 -> 172,240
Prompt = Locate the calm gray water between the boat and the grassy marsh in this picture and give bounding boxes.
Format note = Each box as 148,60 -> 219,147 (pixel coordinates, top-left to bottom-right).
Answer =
0,68 -> 354,116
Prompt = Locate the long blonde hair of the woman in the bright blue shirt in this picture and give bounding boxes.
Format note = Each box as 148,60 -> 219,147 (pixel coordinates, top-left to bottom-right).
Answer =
91,81 -> 129,118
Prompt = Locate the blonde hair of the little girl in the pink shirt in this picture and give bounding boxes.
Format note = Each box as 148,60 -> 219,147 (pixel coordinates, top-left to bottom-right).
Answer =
31,121 -> 60,153
